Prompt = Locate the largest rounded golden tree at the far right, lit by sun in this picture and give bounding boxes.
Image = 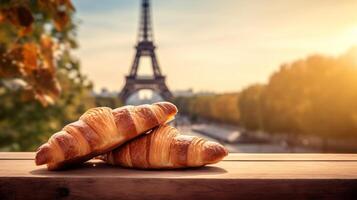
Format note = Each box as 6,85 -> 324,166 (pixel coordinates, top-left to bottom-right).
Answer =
261,49 -> 357,137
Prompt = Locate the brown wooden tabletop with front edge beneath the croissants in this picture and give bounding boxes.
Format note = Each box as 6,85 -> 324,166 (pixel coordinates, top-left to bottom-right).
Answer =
0,153 -> 357,200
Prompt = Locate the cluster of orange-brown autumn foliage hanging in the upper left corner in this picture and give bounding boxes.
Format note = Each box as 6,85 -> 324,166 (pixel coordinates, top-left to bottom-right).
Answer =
0,0 -> 74,106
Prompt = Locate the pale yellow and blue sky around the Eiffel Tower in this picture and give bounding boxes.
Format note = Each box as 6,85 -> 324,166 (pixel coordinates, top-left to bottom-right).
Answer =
73,0 -> 357,93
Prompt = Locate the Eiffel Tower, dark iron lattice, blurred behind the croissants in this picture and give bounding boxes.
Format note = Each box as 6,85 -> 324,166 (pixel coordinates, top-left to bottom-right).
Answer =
119,0 -> 172,103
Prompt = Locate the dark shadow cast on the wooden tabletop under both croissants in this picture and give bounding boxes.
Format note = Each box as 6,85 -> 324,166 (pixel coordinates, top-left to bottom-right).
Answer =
30,160 -> 227,178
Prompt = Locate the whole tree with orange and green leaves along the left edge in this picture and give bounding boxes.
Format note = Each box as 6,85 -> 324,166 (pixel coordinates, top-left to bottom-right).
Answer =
0,0 -> 94,151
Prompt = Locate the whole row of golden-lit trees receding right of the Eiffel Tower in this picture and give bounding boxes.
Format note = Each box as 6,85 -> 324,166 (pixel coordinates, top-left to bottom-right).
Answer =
175,48 -> 357,138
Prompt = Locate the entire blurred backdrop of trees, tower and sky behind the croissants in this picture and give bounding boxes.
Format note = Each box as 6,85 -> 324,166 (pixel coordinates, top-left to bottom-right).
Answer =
0,0 -> 357,153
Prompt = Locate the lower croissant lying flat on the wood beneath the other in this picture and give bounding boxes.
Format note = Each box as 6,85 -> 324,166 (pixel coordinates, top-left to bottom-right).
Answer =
102,125 -> 228,169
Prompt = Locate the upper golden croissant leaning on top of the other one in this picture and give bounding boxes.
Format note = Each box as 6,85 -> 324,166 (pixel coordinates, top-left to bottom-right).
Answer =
35,102 -> 177,170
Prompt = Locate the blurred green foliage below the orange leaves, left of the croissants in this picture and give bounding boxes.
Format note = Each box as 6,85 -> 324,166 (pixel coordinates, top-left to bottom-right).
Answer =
0,72 -> 94,151
